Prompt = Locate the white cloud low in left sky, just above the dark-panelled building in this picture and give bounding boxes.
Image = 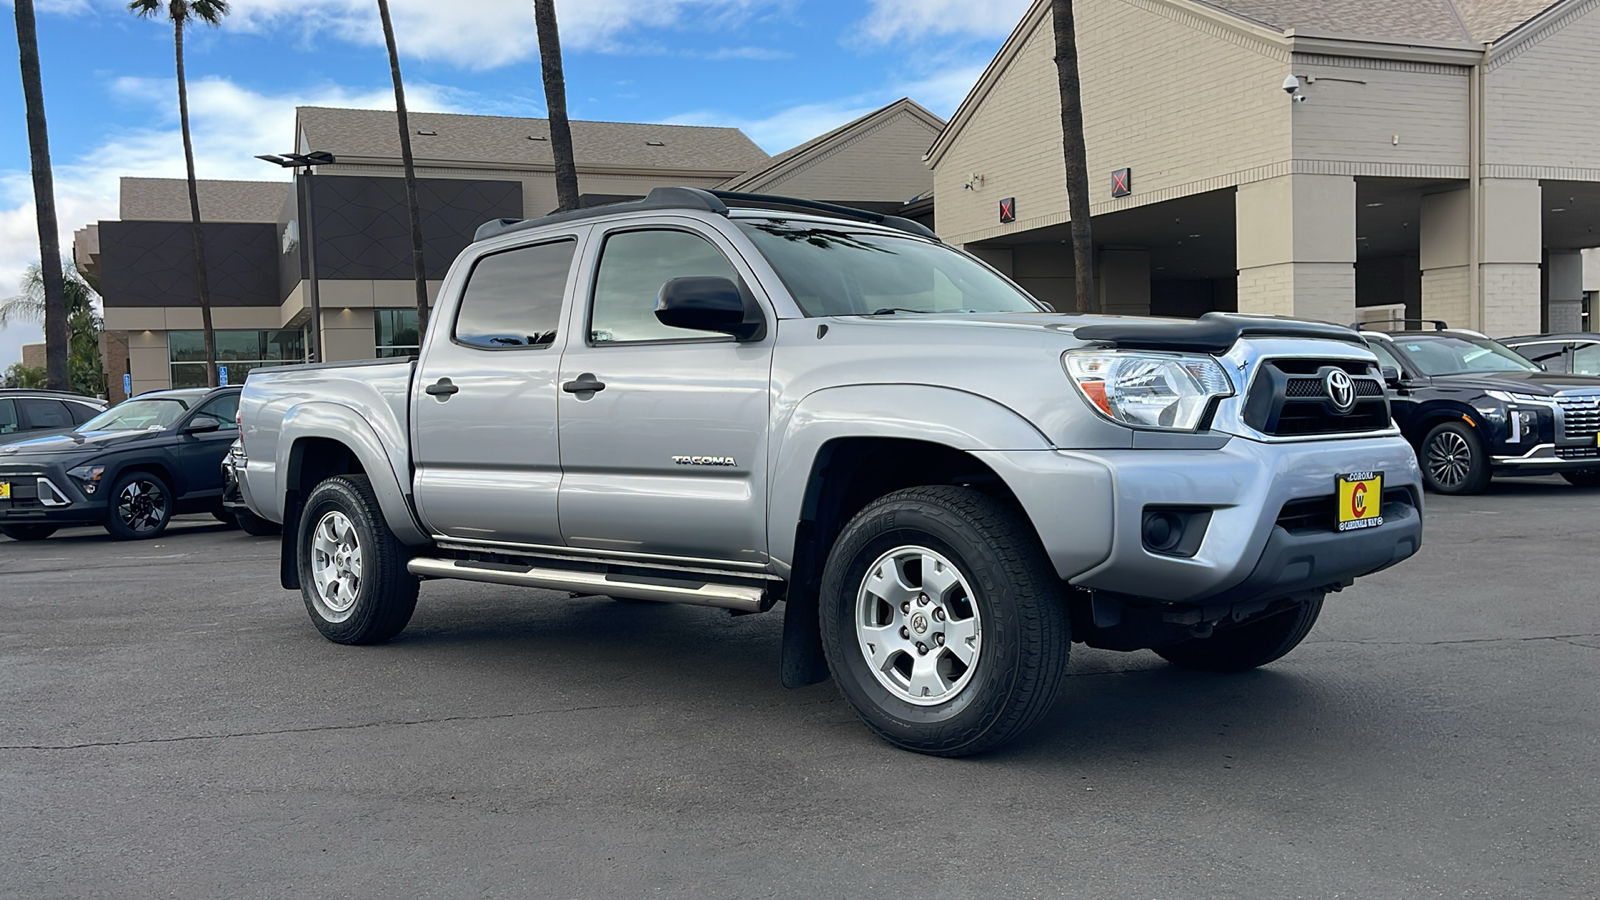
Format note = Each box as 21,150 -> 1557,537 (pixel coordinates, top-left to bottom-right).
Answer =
0,78 -> 459,370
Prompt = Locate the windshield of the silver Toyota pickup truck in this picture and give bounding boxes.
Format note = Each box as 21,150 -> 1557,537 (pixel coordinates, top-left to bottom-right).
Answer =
738,219 -> 1046,315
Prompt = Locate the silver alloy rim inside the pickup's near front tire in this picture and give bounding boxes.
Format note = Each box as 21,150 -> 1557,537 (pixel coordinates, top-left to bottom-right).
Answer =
856,544 -> 982,706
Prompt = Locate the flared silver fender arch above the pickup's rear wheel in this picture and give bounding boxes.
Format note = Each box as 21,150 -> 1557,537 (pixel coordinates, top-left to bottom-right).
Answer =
275,400 -> 432,546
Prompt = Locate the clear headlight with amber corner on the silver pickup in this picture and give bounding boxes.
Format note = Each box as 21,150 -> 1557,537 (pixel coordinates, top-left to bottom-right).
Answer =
1061,349 -> 1234,431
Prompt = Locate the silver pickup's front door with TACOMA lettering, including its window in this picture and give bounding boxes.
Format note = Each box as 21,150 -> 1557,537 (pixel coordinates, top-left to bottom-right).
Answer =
557,223 -> 776,565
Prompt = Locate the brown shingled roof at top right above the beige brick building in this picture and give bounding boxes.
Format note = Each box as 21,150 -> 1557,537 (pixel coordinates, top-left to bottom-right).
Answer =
1206,0 -> 1558,43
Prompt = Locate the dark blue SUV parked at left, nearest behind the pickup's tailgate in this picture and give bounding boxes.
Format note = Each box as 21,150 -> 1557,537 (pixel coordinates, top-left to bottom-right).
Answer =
0,388 -> 240,541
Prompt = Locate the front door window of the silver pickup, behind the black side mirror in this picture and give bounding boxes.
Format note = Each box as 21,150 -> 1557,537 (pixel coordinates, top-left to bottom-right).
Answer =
589,231 -> 739,344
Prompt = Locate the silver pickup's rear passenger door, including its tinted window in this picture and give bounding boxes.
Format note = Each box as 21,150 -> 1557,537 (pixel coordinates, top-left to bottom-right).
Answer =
411,229 -> 587,546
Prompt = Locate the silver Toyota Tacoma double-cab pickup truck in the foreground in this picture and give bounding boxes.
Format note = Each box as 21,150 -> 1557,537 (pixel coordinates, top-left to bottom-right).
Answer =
237,187 -> 1422,756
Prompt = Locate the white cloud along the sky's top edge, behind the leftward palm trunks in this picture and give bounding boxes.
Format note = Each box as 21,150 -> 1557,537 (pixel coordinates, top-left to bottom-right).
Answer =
222,0 -> 786,69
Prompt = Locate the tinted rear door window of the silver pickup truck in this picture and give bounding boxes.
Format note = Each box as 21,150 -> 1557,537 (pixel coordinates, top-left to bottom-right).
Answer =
456,239 -> 578,348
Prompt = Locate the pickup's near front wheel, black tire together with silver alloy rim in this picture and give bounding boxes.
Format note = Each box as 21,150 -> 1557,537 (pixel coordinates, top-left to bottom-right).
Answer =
821,487 -> 1072,756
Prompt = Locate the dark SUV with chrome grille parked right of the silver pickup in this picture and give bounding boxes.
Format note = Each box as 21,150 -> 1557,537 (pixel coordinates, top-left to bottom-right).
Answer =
1355,320 -> 1600,493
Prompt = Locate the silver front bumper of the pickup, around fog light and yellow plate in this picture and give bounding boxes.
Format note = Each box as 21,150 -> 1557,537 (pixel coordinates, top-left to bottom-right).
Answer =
978,436 -> 1422,604
